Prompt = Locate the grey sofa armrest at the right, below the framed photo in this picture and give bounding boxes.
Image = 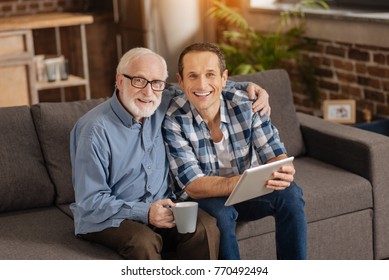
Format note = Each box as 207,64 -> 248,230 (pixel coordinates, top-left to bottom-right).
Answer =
297,113 -> 389,259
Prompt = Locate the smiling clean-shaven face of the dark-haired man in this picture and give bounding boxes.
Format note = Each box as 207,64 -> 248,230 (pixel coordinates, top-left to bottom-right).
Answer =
178,51 -> 228,115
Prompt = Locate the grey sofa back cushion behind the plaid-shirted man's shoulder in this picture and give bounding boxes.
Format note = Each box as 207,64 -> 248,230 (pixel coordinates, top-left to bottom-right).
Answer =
229,69 -> 305,157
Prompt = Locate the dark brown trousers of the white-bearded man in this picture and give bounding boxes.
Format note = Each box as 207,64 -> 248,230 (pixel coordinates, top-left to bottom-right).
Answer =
81,209 -> 220,260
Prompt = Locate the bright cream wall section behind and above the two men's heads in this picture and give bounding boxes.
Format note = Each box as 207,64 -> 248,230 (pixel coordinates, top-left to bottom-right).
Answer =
144,0 -> 214,82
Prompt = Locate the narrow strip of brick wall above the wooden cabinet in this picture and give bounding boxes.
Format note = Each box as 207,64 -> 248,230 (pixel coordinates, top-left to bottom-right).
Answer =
0,0 -> 82,17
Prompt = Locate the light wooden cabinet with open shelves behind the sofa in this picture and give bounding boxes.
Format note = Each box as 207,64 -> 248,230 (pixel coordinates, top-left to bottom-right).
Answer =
0,13 -> 93,107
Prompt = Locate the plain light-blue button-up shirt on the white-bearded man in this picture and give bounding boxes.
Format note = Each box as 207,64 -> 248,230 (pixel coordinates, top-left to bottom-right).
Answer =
70,89 -> 172,234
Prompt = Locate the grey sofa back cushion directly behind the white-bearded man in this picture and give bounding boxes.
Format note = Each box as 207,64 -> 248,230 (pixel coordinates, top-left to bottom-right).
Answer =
31,99 -> 105,204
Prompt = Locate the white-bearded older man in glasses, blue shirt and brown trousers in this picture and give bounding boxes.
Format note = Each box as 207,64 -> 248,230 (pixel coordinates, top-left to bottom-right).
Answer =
70,48 -> 267,259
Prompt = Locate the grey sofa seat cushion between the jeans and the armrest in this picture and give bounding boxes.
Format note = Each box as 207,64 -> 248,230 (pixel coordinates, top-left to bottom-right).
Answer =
294,157 -> 373,222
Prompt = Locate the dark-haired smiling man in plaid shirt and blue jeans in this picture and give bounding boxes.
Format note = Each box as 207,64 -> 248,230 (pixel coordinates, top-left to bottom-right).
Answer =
163,43 -> 306,259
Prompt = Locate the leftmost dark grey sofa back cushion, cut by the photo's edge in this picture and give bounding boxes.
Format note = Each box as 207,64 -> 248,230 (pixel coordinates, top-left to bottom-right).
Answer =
0,106 -> 54,212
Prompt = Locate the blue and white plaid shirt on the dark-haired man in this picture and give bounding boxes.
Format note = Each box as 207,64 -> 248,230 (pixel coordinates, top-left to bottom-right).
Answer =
162,88 -> 286,199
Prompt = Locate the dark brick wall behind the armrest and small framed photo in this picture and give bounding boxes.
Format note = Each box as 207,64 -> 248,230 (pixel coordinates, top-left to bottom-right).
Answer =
294,38 -> 389,118
